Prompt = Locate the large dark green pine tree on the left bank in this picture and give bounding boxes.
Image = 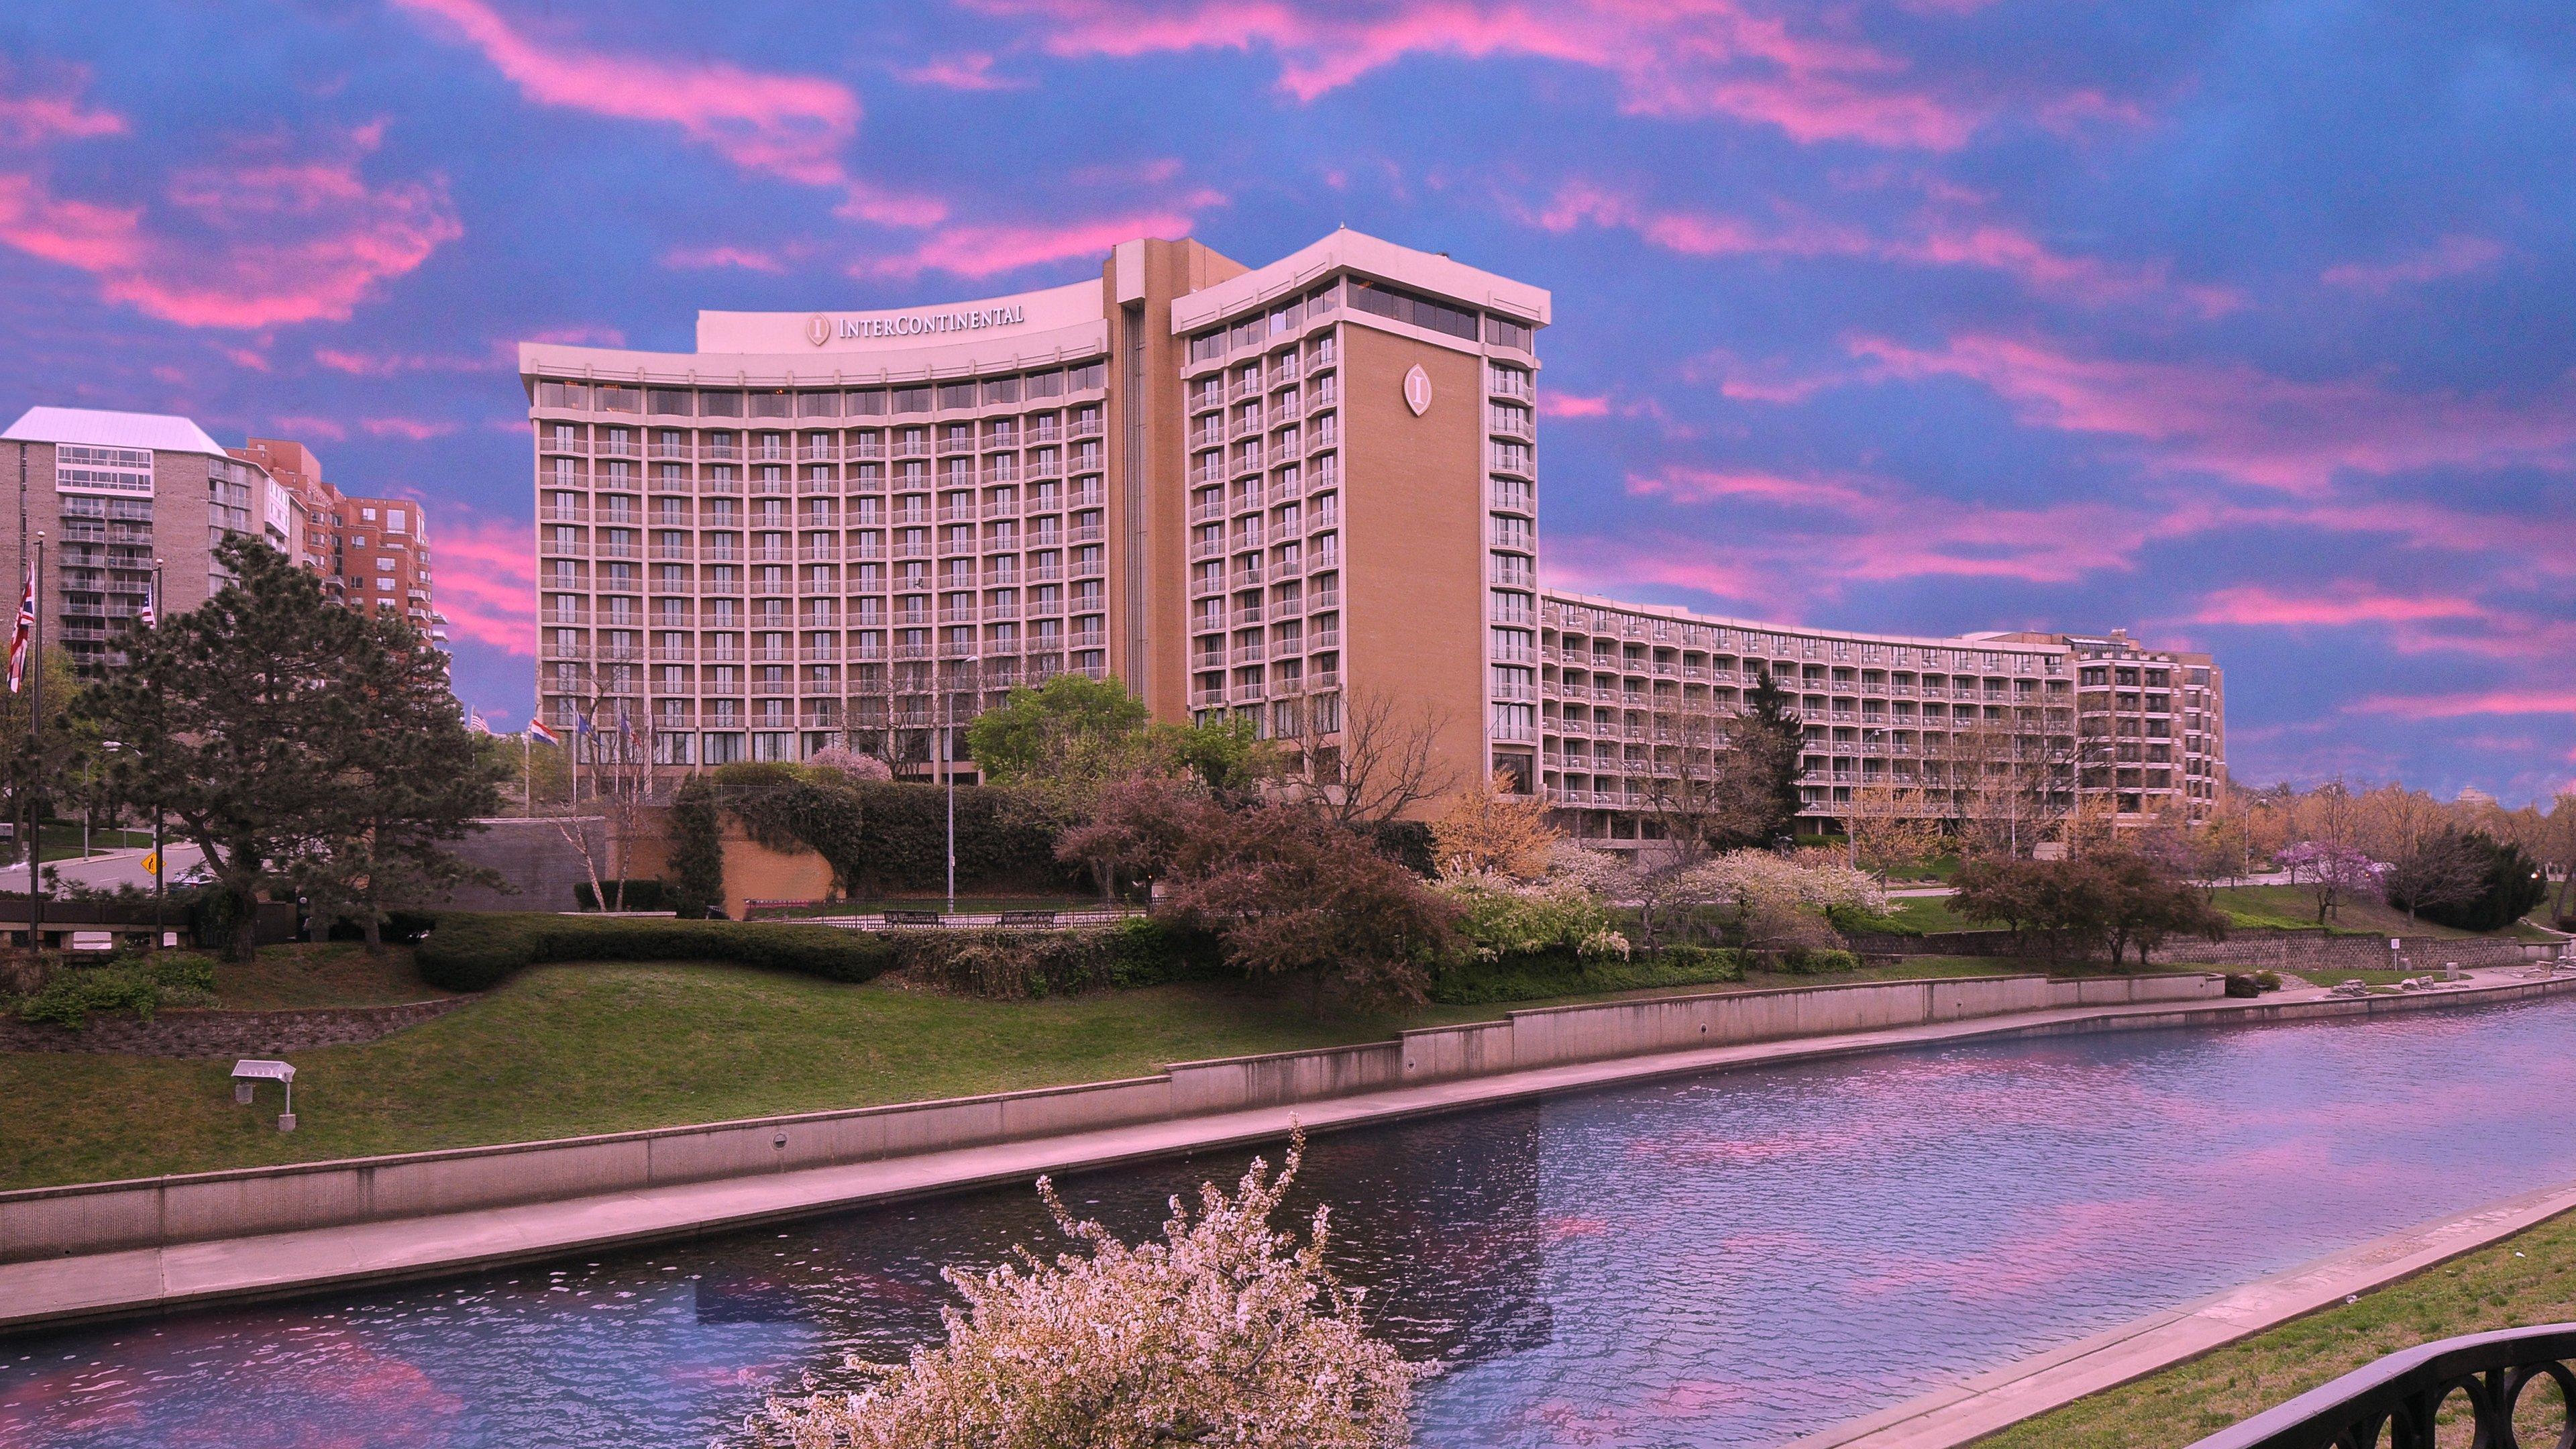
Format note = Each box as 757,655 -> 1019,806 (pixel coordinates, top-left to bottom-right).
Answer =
80,536 -> 500,962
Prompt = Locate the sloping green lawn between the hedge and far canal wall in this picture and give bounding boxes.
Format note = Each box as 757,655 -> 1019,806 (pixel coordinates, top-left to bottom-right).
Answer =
0,949 -> 1996,1189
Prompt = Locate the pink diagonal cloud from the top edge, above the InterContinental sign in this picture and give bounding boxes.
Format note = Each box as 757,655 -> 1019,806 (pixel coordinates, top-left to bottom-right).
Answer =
394,0 -> 948,227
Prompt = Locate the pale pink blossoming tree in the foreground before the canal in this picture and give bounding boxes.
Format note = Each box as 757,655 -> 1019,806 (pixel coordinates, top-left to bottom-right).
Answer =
755,1132 -> 1430,1449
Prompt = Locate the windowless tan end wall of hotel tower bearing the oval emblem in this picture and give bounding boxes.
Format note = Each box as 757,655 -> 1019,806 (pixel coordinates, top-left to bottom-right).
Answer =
1342,325 -> 1489,815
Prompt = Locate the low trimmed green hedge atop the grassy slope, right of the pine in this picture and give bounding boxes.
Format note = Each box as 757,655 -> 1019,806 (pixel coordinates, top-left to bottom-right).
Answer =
415,910 -> 894,990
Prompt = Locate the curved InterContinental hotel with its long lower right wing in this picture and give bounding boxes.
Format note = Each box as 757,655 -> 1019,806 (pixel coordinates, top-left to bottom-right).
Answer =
521,229 -> 2220,838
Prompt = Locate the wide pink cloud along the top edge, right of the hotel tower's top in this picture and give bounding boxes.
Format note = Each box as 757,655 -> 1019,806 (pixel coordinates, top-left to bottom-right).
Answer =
976,0 -> 1986,150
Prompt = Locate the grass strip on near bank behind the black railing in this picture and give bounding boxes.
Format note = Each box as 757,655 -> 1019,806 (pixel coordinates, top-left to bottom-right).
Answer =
1978,1196 -> 2576,1449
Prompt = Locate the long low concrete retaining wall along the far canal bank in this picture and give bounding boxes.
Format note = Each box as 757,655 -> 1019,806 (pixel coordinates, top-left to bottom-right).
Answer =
0,975 -> 2223,1263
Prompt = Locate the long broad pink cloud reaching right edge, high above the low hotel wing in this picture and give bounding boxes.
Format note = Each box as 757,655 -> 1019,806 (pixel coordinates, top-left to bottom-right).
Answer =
1849,335 -> 2576,495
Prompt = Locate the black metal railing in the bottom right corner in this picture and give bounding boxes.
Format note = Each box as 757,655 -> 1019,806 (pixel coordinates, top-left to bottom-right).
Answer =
2192,1323 -> 2576,1449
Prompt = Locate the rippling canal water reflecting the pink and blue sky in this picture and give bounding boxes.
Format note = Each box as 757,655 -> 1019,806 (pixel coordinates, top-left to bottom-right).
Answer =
15,1000 -> 2576,1449
